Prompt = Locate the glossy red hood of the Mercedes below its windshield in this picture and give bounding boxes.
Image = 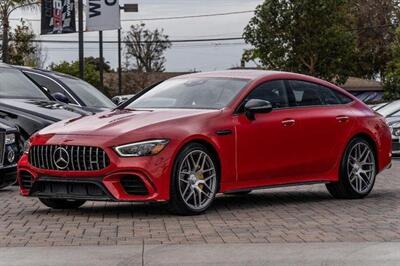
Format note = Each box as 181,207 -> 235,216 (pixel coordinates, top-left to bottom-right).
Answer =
40,109 -> 220,137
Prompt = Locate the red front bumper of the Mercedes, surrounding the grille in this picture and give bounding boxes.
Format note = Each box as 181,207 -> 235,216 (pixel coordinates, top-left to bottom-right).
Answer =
17,136 -> 174,202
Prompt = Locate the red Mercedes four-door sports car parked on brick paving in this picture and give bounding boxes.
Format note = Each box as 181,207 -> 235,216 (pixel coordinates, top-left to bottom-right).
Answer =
18,70 -> 391,214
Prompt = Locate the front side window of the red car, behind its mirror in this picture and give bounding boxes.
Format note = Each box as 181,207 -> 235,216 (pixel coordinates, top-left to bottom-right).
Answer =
246,80 -> 289,108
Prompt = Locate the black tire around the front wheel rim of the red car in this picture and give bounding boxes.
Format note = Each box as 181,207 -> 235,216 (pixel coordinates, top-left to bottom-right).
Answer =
168,143 -> 219,215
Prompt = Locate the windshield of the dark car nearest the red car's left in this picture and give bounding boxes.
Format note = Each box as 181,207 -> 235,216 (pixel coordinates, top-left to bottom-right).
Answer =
57,75 -> 116,108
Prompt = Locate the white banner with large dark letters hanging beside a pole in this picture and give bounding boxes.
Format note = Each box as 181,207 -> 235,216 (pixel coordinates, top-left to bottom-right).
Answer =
86,0 -> 121,31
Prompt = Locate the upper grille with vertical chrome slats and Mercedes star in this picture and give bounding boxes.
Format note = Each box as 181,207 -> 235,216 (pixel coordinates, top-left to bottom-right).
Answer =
29,145 -> 110,171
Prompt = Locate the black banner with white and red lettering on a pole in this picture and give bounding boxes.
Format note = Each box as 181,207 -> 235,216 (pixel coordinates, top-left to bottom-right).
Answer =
41,0 -> 76,34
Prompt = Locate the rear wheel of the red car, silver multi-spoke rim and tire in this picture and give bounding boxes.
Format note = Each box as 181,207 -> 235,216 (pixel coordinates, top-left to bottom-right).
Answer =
326,138 -> 377,199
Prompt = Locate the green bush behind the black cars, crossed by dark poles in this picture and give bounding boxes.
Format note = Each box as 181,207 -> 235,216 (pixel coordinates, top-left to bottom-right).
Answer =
50,57 -> 109,95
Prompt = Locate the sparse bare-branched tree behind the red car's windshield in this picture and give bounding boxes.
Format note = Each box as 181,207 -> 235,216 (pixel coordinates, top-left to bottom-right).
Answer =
124,24 -> 171,72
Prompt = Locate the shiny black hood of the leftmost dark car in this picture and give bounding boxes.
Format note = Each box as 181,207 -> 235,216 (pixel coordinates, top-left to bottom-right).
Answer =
0,98 -> 92,122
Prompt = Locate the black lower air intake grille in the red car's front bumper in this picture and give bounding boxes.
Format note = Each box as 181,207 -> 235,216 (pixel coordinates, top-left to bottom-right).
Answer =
30,178 -> 112,200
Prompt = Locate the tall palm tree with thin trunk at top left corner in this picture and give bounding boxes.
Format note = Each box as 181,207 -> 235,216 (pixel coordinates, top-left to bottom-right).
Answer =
0,0 -> 39,63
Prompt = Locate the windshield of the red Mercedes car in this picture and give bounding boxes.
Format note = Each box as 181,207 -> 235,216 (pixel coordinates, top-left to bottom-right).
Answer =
126,78 -> 248,109
